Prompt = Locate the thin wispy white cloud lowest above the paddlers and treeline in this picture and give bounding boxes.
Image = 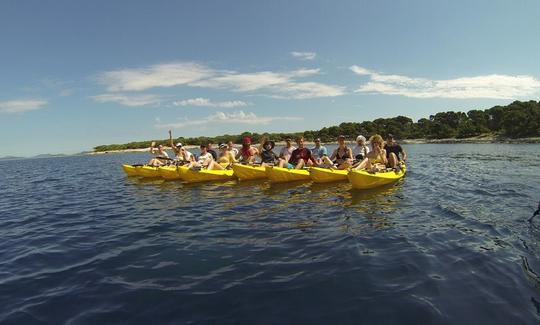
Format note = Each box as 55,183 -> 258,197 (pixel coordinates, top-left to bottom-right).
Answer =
156,111 -> 303,128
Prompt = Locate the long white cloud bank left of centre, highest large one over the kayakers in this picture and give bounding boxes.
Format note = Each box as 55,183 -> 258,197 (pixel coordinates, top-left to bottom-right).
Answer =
98,62 -> 345,99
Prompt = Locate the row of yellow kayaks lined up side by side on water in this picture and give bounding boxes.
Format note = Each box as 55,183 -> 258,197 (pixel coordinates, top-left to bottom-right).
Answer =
122,164 -> 406,189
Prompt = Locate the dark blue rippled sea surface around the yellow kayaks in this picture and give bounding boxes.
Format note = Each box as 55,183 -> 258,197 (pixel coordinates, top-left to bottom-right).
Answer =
0,145 -> 540,324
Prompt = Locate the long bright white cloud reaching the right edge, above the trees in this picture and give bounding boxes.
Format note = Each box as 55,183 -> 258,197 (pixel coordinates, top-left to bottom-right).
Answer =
350,65 -> 540,99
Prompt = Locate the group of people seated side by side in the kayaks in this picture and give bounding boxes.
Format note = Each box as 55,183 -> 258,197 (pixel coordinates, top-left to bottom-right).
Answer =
148,131 -> 407,172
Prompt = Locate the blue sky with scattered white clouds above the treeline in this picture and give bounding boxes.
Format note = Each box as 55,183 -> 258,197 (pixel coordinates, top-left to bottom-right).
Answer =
0,0 -> 540,157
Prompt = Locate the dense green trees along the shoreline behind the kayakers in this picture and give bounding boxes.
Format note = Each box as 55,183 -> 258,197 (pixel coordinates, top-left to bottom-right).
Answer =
94,100 -> 540,151
